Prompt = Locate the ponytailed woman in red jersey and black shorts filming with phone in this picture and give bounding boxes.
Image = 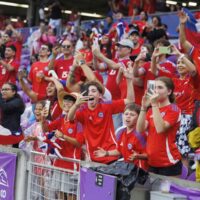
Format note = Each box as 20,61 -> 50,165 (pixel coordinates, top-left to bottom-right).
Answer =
136,77 -> 182,176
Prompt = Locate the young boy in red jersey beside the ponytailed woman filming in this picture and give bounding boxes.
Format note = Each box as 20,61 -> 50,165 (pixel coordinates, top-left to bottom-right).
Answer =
94,104 -> 147,170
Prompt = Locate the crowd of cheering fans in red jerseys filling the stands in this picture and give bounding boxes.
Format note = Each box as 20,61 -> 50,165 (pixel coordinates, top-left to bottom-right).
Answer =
0,1 -> 200,199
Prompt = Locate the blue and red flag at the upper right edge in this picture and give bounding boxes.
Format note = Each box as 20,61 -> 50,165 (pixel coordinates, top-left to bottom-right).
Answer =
183,8 -> 200,48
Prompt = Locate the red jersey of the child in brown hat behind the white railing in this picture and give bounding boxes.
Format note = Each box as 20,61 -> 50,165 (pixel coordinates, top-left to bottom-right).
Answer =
48,116 -> 82,170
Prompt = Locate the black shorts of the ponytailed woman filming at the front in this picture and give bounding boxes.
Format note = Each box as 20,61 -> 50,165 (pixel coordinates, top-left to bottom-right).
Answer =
149,161 -> 182,176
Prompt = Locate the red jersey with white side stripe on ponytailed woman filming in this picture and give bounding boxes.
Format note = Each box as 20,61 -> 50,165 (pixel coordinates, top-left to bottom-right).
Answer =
146,104 -> 181,167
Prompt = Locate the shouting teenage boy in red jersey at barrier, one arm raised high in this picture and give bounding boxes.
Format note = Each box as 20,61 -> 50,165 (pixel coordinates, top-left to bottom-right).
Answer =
68,66 -> 134,163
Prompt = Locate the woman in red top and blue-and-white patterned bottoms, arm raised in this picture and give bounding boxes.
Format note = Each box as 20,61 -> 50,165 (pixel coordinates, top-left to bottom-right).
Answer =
172,46 -> 199,165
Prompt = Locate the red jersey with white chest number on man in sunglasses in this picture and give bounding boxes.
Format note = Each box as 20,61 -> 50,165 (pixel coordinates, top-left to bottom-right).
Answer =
54,57 -> 82,82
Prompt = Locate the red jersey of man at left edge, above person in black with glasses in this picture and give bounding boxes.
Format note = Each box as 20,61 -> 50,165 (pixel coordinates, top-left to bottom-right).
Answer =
0,59 -> 20,88
